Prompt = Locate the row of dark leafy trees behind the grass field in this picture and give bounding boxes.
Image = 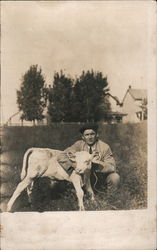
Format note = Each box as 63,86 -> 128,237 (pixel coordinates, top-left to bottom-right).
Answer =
17,65 -> 111,122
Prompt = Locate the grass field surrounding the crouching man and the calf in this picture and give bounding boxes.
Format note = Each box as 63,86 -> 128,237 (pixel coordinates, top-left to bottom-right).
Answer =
1,122 -> 147,212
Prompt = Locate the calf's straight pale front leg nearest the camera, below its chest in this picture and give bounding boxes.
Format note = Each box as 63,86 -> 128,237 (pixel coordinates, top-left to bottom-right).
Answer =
70,171 -> 85,211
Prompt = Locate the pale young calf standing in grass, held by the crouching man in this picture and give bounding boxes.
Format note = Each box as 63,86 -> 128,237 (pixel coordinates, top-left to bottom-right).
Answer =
7,148 -> 94,212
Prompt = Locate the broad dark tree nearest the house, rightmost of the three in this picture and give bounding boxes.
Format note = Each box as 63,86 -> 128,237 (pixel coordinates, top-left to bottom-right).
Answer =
72,70 -> 110,122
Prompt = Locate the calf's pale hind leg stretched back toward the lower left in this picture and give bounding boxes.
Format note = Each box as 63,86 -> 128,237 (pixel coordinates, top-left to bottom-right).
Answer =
7,177 -> 32,212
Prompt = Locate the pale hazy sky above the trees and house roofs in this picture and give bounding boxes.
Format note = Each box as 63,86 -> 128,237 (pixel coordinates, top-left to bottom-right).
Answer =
1,1 -> 155,122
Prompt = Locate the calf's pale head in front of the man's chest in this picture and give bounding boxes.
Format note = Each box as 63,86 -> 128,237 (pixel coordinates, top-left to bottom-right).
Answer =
67,151 -> 94,174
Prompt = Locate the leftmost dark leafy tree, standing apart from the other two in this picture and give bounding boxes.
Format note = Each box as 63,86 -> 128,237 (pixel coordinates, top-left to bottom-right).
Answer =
17,65 -> 45,124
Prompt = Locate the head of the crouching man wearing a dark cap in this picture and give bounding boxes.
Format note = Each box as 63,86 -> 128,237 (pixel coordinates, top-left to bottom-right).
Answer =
80,124 -> 98,145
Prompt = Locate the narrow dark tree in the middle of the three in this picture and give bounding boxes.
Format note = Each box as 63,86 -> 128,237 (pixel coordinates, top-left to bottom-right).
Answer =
48,70 -> 73,122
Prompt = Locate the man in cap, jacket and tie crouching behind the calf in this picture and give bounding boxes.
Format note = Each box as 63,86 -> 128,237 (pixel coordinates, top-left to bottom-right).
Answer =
65,124 -> 120,192
